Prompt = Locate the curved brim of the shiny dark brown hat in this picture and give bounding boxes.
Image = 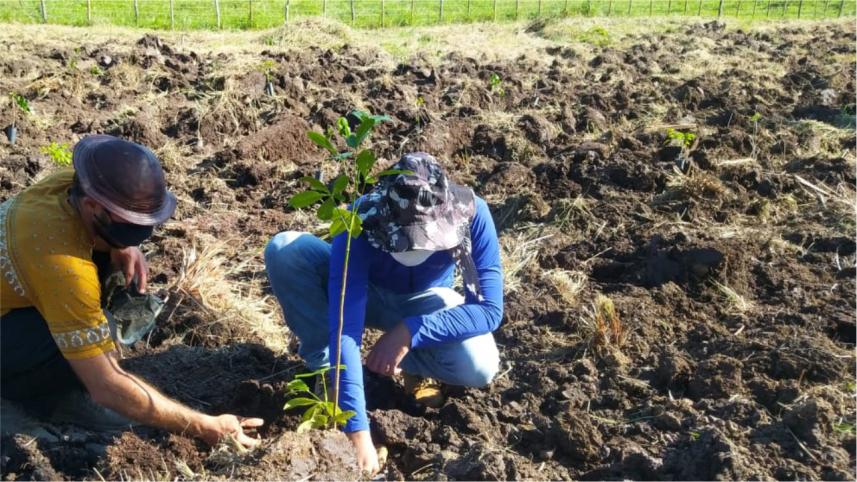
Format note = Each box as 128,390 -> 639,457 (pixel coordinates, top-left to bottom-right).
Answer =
72,134 -> 178,226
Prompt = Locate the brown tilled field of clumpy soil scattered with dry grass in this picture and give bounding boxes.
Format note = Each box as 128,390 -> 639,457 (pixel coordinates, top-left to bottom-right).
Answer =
0,17 -> 857,480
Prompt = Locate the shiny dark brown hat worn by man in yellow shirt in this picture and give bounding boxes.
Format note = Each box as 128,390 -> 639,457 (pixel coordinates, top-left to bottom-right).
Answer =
72,134 -> 176,226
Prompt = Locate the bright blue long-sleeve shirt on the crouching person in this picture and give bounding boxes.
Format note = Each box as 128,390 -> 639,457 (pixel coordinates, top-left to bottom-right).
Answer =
328,197 -> 503,433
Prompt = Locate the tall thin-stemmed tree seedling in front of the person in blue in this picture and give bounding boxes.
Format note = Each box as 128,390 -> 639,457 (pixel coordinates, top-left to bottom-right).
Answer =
289,111 -> 407,425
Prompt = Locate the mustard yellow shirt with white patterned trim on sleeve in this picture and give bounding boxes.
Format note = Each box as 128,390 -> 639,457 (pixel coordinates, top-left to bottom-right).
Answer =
0,170 -> 114,360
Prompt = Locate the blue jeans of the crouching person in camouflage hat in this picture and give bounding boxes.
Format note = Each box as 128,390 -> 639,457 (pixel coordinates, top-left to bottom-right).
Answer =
265,231 -> 500,387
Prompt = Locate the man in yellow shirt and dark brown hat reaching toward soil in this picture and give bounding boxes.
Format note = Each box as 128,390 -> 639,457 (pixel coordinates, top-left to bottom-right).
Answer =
0,135 -> 263,446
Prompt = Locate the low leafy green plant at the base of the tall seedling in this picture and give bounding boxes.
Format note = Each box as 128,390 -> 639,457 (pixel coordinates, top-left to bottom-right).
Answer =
283,366 -> 355,433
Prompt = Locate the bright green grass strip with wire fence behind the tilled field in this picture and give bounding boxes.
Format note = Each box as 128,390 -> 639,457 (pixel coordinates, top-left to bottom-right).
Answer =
0,0 -> 857,30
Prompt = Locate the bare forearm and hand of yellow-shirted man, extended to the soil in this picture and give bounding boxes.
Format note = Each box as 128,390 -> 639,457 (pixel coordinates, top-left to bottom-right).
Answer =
69,351 -> 264,446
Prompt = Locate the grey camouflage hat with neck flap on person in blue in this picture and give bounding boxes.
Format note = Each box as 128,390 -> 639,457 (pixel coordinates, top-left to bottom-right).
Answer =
357,152 -> 482,301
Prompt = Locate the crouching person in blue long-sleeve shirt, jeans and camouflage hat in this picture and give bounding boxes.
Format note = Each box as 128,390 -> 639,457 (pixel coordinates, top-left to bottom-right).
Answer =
265,152 -> 503,475
